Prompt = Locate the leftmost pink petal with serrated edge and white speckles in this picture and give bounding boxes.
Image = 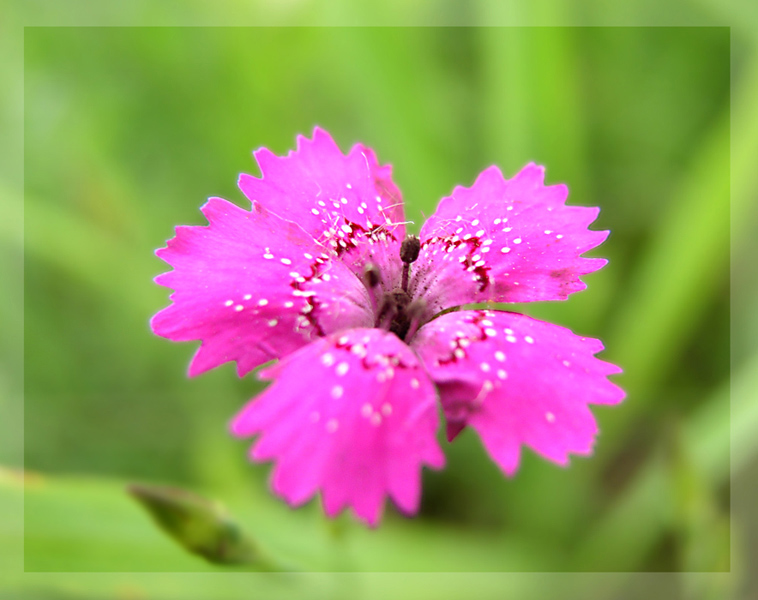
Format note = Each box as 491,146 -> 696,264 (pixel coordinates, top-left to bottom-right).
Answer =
151,198 -> 373,376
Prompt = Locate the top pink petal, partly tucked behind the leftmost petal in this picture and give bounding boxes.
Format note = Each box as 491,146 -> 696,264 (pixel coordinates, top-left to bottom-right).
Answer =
239,127 -> 405,289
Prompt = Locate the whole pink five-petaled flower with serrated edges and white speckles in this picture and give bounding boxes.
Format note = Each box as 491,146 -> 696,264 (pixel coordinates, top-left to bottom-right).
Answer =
152,128 -> 624,525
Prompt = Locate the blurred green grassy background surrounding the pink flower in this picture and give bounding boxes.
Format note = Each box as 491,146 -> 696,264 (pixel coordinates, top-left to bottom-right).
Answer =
0,2 -> 758,598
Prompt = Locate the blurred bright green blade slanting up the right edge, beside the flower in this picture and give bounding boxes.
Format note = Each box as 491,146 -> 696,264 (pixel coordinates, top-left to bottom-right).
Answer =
606,50 -> 758,426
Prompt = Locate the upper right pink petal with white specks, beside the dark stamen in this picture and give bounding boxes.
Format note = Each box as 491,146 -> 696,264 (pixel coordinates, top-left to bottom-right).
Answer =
411,164 -> 608,312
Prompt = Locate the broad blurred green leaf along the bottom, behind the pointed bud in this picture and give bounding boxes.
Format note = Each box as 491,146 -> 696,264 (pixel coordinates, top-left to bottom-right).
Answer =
17,476 -> 560,573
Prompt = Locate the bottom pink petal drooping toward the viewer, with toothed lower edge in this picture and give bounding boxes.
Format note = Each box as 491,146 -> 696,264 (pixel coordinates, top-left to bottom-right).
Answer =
232,329 -> 444,525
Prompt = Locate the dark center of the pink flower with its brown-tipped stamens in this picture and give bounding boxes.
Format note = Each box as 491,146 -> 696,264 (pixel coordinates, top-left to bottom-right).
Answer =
365,235 -> 426,342
